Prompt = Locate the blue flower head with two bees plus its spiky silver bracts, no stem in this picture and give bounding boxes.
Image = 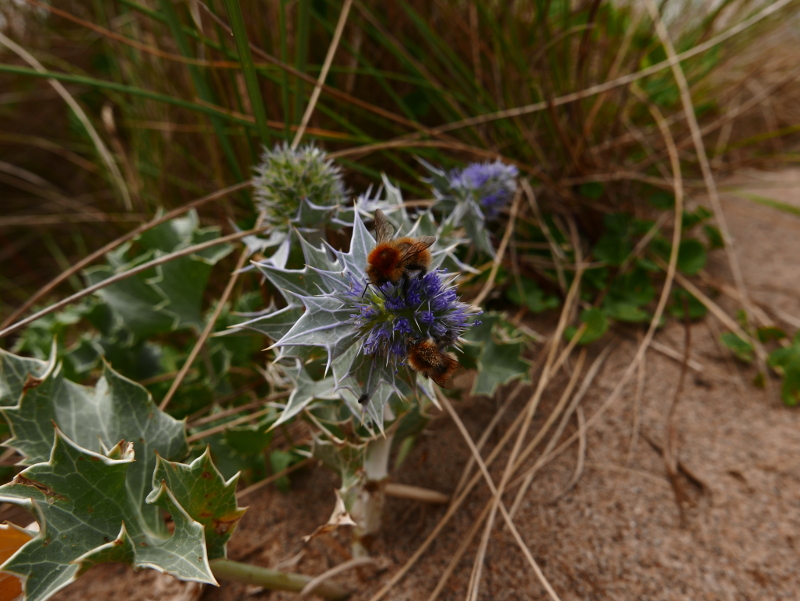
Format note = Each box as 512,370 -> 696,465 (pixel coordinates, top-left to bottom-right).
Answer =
247,206 -> 480,429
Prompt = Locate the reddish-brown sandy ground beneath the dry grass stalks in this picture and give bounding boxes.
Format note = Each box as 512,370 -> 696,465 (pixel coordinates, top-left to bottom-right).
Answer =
50,171 -> 800,601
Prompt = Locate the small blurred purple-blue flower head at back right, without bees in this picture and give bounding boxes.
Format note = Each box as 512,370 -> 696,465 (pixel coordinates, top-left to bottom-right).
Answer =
448,161 -> 519,219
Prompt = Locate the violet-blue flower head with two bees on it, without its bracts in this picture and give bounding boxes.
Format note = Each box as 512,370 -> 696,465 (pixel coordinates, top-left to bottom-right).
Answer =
341,270 -> 480,364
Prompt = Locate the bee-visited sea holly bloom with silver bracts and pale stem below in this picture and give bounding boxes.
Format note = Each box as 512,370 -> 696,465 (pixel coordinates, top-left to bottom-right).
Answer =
242,213 -> 479,553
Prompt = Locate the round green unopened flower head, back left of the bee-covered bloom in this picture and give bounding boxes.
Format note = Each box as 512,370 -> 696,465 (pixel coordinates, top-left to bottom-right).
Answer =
253,143 -> 346,228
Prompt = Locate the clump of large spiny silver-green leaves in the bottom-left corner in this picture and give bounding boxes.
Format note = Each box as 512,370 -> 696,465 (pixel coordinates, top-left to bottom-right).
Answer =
0,349 -> 244,600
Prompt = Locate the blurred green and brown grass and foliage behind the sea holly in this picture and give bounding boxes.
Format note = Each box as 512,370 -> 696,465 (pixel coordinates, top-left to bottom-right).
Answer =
0,0 -> 800,477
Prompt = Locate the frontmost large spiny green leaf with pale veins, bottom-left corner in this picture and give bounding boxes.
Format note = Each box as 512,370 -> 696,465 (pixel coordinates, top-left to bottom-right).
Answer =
0,429 -> 216,601
